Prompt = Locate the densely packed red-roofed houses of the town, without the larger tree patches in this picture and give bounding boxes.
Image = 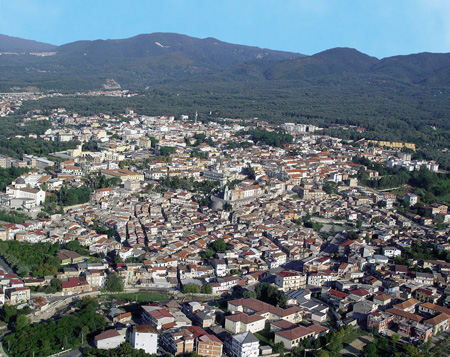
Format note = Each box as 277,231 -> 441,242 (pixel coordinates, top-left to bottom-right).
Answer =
0,95 -> 450,356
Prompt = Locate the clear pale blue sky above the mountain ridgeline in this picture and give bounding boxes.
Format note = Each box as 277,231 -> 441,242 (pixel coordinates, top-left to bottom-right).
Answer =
0,0 -> 450,58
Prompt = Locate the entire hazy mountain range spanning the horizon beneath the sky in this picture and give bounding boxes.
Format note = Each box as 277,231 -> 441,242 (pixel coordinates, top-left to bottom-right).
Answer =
0,33 -> 450,91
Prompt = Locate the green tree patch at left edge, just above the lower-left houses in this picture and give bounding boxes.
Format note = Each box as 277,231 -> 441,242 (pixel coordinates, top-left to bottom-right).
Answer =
0,240 -> 61,278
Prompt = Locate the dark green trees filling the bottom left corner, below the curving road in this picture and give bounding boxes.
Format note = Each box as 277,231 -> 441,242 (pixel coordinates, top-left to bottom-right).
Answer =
3,297 -> 107,357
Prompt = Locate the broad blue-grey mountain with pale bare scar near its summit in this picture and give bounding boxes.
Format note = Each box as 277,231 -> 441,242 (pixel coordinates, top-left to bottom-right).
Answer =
0,33 -> 303,91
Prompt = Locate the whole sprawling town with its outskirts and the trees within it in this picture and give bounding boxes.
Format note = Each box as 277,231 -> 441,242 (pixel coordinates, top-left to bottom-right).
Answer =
0,91 -> 450,357
